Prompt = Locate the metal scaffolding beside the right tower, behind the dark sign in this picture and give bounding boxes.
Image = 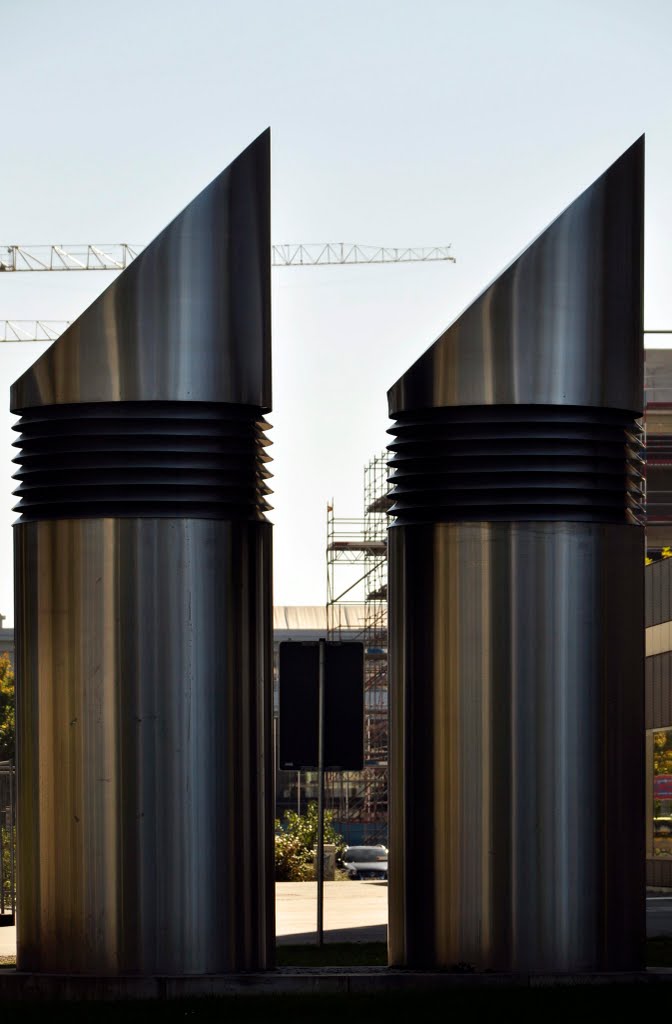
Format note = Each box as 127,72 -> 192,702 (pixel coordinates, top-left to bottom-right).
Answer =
326,452 -> 390,845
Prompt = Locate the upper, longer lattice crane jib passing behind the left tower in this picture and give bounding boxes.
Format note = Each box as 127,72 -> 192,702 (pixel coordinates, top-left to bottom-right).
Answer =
0,242 -> 456,272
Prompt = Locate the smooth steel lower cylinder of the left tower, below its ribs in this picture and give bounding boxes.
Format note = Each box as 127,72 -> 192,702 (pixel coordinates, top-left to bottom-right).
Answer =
14,518 -> 275,974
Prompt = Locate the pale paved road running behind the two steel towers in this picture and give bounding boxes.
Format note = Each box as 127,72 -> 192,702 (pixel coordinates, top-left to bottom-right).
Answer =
0,882 -> 672,956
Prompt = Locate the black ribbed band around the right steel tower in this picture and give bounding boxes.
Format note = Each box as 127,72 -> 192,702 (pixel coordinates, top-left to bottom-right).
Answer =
388,406 -> 642,525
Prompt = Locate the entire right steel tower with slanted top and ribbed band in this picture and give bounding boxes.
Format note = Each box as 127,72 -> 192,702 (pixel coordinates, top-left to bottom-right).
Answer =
388,140 -> 645,972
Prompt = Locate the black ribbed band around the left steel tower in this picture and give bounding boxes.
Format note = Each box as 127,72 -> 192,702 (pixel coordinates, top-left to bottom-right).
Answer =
13,401 -> 270,522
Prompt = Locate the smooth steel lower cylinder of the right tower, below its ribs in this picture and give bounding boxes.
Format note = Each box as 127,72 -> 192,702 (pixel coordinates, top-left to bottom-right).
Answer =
388,522 -> 645,971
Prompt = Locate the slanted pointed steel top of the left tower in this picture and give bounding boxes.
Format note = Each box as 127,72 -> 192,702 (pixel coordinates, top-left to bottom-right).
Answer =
10,130 -> 271,412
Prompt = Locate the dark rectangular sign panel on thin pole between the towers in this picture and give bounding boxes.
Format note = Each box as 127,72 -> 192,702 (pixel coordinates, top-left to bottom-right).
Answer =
279,641 -> 364,771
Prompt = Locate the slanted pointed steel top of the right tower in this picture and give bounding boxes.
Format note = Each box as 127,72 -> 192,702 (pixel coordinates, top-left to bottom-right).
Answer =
387,135 -> 644,417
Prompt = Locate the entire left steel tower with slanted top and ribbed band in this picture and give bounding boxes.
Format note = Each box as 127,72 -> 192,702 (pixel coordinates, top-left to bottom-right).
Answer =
12,133 -> 275,975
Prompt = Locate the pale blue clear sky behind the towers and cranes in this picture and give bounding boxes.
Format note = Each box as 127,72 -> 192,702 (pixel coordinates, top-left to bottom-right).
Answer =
0,0 -> 672,624
